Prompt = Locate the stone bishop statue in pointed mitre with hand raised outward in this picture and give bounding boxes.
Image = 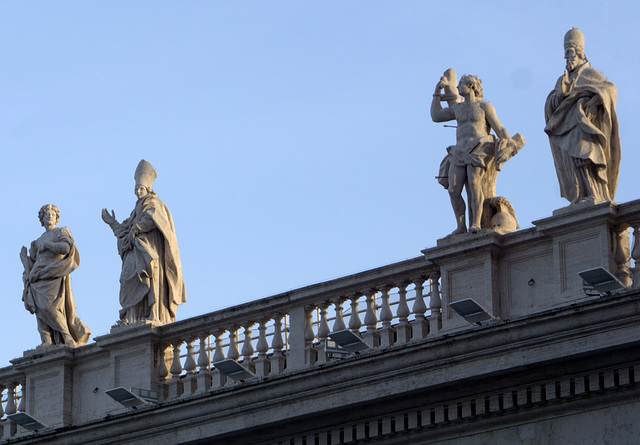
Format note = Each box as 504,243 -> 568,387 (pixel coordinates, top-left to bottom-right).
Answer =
102,159 -> 187,324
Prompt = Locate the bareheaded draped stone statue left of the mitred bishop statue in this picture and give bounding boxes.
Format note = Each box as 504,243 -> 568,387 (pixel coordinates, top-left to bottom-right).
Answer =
20,204 -> 91,347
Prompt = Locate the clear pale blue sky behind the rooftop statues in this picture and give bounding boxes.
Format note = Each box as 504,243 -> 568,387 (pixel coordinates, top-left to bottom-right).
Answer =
0,0 -> 640,366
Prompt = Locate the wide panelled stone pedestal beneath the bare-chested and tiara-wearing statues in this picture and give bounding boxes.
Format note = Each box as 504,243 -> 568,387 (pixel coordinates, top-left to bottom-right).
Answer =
422,203 -> 630,333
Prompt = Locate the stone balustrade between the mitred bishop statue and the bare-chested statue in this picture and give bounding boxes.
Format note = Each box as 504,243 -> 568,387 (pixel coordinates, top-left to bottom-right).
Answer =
158,257 -> 441,399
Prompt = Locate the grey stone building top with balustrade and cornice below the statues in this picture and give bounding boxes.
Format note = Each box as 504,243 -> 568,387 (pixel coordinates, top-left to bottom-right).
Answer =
0,201 -> 640,445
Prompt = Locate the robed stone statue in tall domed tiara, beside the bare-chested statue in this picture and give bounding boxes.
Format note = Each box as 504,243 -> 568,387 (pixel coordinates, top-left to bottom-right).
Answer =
544,28 -> 620,204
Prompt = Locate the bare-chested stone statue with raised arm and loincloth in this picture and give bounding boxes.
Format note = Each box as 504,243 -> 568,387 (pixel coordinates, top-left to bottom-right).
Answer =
431,69 -> 525,235
